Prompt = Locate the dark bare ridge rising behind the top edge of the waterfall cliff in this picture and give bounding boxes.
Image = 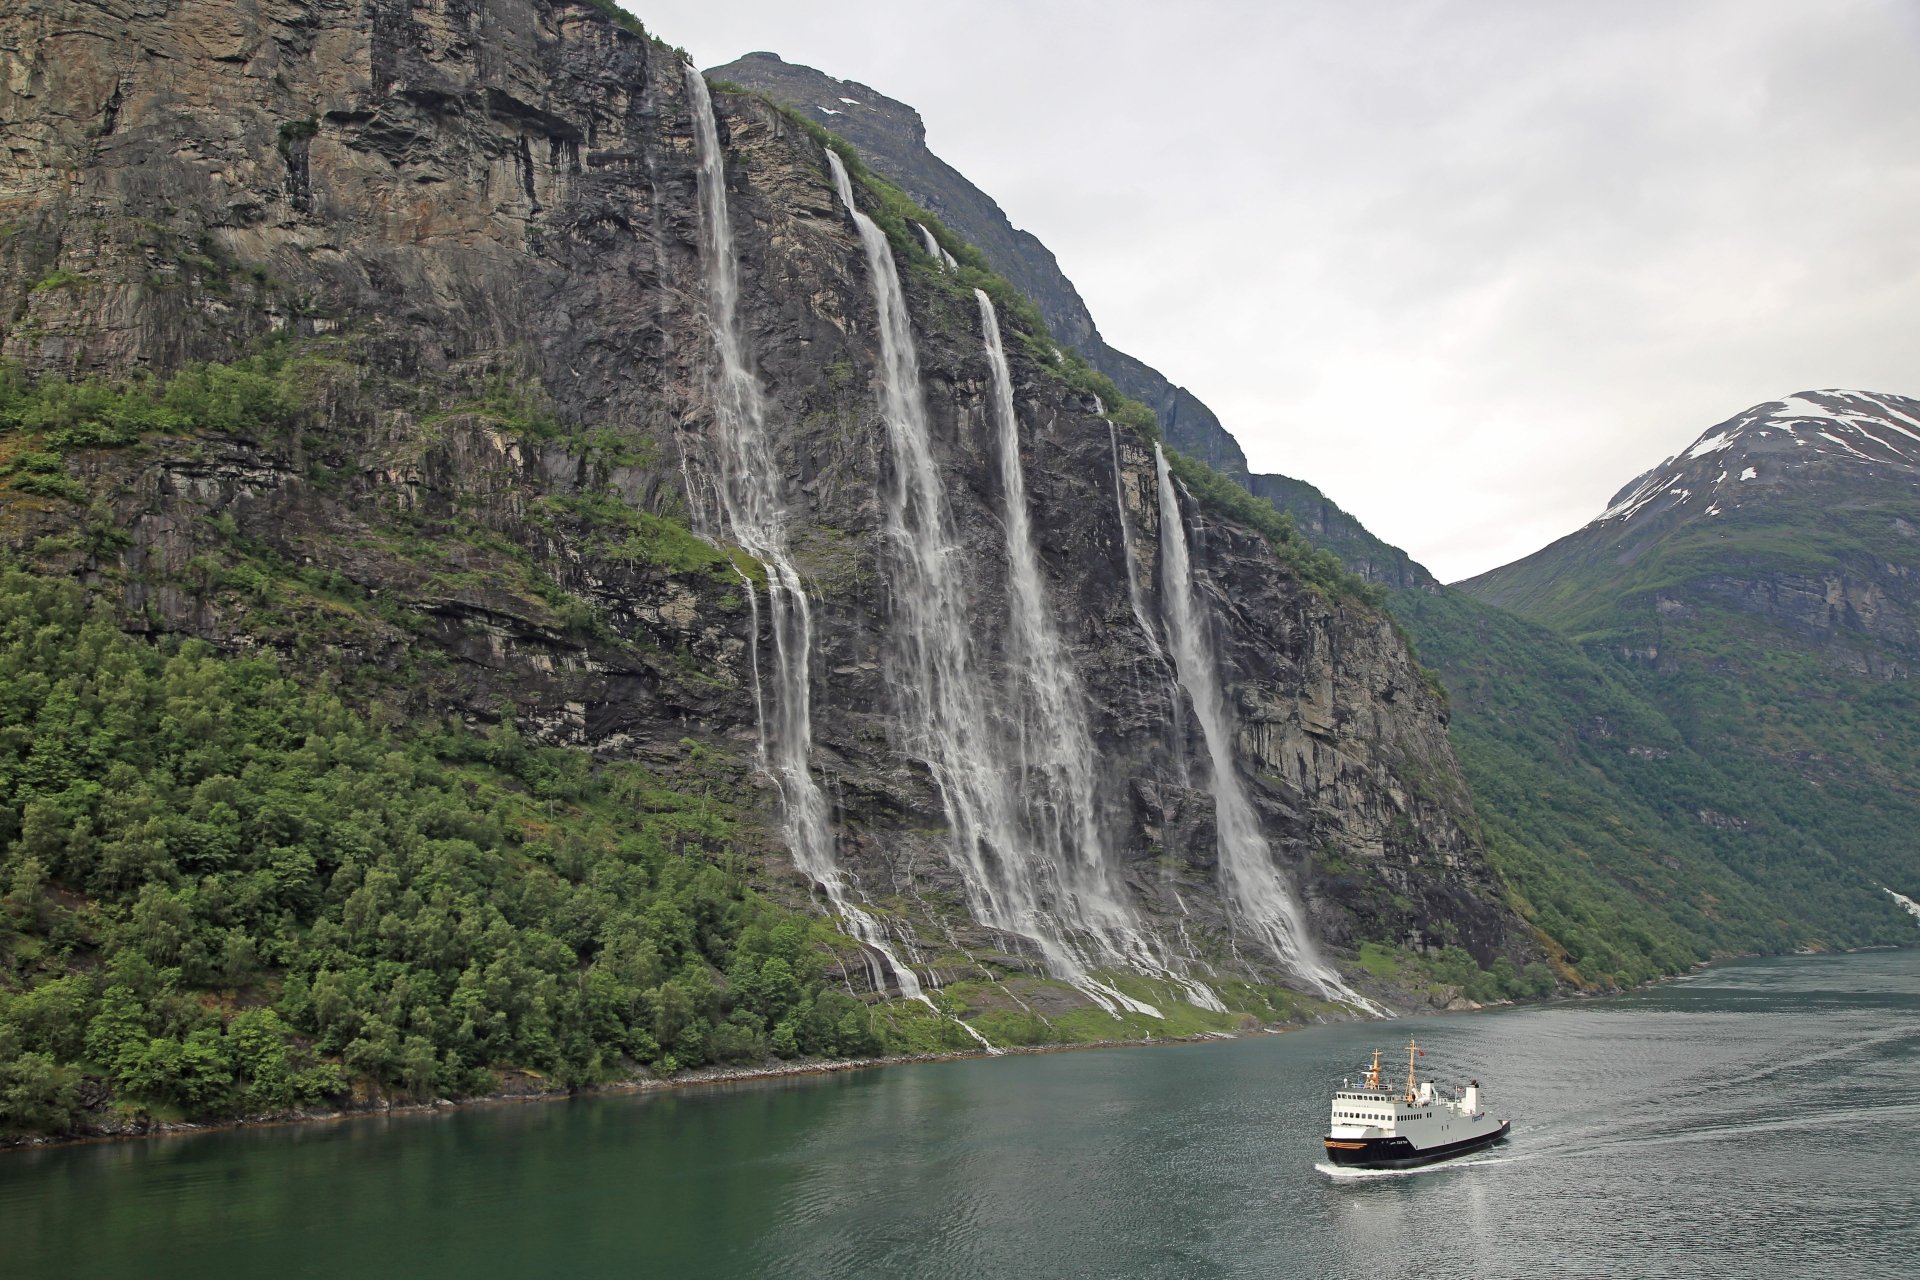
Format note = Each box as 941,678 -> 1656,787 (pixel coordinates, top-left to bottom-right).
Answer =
707,54 -> 1248,484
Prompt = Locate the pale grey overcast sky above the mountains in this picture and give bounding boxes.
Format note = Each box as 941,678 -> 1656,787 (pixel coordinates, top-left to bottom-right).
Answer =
637,0 -> 1920,581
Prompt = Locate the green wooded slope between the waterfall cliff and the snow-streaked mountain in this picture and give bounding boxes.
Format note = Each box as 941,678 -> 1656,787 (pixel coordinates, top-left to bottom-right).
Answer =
1394,591 -> 1908,983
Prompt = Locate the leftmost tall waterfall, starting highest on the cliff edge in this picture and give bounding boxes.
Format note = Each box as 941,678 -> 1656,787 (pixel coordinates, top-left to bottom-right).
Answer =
685,65 -> 925,1005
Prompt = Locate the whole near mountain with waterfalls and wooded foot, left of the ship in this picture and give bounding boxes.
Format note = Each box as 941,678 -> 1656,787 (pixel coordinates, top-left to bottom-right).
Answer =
0,0 -> 1528,1130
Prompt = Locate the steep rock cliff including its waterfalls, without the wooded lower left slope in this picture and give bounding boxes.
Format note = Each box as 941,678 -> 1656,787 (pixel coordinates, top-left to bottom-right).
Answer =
0,0 -> 1534,1128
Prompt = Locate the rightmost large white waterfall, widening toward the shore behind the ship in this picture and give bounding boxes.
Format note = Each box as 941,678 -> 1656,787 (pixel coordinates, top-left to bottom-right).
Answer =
1154,445 -> 1380,1011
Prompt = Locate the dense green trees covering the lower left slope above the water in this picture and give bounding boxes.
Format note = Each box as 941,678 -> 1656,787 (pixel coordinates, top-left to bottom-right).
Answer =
0,568 -> 906,1130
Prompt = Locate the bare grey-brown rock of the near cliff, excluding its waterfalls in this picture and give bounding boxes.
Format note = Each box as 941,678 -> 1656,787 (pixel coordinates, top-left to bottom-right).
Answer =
0,0 -> 1528,1004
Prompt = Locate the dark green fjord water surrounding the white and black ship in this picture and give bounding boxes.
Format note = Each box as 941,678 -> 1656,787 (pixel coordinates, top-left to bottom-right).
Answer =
0,952 -> 1920,1280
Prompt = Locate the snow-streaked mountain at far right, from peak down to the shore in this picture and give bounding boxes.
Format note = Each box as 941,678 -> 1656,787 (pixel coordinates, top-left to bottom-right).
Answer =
1451,391 -> 1920,955
